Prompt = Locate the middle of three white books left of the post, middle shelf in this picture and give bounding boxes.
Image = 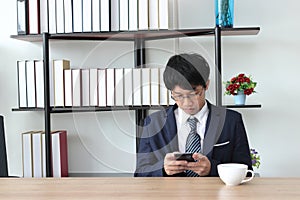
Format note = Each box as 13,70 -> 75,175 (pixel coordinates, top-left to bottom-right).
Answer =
26,60 -> 36,108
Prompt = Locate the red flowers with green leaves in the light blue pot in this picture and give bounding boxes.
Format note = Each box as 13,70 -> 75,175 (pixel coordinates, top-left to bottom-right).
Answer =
224,74 -> 257,95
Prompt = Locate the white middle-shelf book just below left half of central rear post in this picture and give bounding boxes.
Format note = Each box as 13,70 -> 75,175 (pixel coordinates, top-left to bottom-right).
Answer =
132,68 -> 142,106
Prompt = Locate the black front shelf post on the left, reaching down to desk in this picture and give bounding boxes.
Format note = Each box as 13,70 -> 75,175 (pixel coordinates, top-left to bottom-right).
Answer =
43,33 -> 53,177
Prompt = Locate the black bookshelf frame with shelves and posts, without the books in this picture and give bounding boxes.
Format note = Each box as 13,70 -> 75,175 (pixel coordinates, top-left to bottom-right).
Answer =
11,27 -> 261,177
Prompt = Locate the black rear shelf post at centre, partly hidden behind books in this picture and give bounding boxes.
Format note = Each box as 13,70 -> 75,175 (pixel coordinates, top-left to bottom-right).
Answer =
134,38 -> 147,151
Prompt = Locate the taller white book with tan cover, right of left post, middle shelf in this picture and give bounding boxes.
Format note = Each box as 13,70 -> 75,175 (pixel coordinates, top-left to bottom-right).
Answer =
53,60 -> 70,107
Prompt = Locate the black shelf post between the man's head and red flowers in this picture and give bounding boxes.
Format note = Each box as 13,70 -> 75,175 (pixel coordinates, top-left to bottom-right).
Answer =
215,26 -> 222,106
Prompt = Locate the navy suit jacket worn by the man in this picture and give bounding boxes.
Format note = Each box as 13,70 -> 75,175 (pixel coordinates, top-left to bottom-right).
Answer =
134,102 -> 252,177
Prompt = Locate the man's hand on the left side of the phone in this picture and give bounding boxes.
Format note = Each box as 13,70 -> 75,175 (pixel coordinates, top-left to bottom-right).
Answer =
164,153 -> 188,175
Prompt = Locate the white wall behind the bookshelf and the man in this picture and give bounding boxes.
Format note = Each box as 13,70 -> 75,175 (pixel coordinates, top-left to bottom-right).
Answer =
0,0 -> 300,177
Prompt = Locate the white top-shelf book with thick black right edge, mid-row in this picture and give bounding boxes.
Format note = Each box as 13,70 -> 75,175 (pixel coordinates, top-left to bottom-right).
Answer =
100,0 -> 111,31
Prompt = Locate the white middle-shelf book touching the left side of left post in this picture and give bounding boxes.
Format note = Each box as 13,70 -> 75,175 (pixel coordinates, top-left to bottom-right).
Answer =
35,60 -> 45,108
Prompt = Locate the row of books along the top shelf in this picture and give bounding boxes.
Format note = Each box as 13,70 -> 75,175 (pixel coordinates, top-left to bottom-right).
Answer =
17,0 -> 177,34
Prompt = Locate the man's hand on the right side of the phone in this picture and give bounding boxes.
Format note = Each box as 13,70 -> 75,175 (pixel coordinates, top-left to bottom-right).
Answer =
186,153 -> 211,176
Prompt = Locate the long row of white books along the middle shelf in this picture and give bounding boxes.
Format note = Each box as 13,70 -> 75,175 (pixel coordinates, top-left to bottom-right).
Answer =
17,60 -> 174,108
